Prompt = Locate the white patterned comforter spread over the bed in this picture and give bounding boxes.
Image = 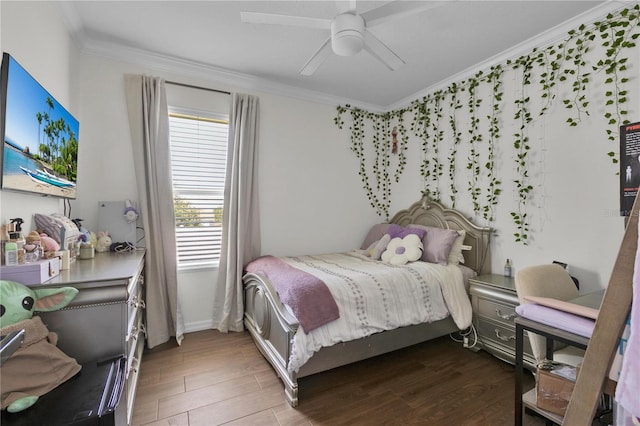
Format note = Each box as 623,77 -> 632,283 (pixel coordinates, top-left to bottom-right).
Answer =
281,251 -> 471,372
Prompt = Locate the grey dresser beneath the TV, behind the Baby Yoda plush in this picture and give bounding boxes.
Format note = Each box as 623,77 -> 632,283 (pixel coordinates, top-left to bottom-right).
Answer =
37,251 -> 145,425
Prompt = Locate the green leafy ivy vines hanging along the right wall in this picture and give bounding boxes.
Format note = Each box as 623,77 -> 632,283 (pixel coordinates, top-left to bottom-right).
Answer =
334,3 -> 640,245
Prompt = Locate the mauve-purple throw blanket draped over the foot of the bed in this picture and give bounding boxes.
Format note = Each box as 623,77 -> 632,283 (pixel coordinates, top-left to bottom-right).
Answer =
245,256 -> 340,333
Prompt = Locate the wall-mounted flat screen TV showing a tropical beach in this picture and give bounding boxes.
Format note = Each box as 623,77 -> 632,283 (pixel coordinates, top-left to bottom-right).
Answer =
0,53 -> 80,198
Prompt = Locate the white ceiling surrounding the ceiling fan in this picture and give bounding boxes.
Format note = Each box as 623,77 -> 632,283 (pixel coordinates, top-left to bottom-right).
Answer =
61,0 -> 621,109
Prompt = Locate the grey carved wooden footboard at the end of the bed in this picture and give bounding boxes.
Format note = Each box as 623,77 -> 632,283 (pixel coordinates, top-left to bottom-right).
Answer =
243,273 -> 299,407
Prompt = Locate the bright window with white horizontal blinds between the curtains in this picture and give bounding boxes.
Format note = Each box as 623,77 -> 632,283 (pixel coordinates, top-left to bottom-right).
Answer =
169,109 -> 229,269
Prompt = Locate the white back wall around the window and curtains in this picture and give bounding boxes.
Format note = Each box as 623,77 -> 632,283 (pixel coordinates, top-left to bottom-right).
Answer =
71,50 -> 376,331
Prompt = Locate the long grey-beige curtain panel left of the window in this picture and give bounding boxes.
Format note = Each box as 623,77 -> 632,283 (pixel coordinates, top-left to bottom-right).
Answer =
125,74 -> 184,348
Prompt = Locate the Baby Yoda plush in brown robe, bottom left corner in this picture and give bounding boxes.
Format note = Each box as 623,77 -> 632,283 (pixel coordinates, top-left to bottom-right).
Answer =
0,280 -> 82,413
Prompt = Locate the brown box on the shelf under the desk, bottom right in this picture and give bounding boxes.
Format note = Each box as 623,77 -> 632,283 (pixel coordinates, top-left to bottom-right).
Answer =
536,361 -> 577,416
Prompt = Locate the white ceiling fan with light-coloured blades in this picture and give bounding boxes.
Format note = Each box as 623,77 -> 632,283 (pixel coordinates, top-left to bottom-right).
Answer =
240,0 -> 444,75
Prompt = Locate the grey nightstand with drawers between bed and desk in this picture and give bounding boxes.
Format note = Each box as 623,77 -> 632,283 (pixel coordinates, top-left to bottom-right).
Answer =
469,274 -> 536,371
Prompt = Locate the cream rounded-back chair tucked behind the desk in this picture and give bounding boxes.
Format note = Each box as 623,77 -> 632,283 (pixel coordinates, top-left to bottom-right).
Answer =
515,264 -> 584,366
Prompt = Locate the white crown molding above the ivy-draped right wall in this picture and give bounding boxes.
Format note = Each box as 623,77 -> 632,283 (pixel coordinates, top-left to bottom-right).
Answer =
385,0 -> 638,112
